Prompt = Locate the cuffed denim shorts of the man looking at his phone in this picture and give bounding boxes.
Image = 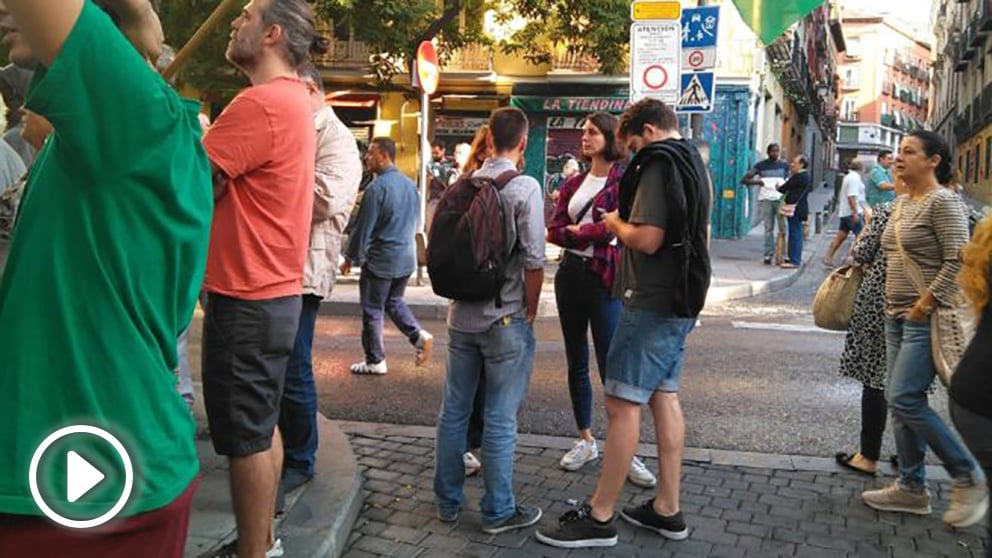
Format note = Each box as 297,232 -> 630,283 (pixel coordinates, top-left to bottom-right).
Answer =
604,306 -> 696,405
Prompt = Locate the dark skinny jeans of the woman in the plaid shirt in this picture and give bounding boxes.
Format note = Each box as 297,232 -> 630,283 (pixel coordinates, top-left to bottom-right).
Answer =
555,252 -> 622,430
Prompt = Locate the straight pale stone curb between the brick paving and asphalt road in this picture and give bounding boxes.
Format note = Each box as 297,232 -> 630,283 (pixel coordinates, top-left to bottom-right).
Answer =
334,421 -> 950,481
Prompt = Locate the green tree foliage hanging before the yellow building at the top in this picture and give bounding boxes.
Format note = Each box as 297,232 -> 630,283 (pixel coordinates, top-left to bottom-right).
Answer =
156,0 -> 630,98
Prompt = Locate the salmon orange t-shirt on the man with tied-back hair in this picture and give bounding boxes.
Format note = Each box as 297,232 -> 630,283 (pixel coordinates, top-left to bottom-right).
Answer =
203,78 -> 316,300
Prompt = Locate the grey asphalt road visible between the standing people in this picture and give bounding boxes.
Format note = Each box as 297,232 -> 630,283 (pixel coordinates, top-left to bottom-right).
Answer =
304,234 -> 947,462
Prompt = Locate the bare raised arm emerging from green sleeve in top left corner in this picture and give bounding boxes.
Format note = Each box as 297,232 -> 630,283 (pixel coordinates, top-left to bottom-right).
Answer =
3,0 -> 83,67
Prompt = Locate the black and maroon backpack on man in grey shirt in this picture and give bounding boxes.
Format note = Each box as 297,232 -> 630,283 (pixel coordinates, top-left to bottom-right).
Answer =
427,170 -> 521,307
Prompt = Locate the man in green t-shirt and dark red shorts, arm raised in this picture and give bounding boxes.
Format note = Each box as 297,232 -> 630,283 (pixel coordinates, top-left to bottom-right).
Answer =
0,0 -> 212,558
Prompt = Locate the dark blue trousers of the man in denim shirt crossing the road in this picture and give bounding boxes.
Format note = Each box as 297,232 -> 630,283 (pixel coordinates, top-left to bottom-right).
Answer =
358,268 -> 420,364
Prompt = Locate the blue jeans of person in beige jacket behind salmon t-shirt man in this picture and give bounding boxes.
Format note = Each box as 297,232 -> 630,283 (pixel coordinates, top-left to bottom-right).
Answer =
279,295 -> 320,477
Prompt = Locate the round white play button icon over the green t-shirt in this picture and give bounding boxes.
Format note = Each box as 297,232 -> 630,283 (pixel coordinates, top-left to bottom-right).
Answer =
28,424 -> 134,529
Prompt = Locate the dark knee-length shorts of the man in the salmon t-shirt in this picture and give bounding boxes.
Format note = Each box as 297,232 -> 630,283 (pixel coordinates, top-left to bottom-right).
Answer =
202,293 -> 302,457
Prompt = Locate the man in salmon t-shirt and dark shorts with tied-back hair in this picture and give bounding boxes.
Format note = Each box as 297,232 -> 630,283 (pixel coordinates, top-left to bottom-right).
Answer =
203,0 -> 326,556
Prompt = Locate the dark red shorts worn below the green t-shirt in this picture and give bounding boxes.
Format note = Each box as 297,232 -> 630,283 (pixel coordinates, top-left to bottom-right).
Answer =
0,478 -> 200,558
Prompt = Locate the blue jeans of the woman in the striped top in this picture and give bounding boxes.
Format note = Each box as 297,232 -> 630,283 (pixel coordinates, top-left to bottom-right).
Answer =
885,318 -> 976,489
